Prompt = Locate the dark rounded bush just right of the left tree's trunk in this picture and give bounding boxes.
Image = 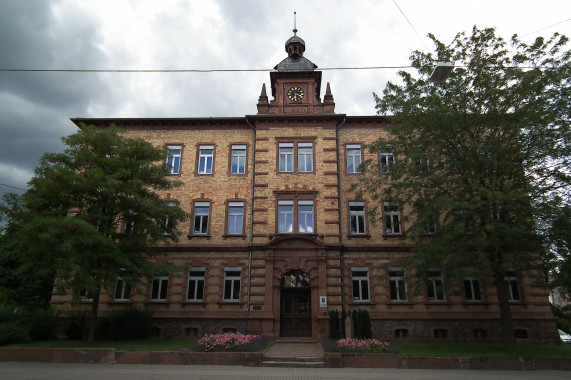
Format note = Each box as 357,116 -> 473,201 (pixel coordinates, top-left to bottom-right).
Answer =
97,307 -> 153,340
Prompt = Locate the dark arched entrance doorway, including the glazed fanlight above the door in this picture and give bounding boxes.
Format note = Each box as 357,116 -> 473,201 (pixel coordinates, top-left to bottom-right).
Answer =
280,270 -> 311,337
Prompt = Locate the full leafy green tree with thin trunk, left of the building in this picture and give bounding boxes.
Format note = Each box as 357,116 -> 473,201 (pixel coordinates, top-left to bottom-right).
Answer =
2,126 -> 188,341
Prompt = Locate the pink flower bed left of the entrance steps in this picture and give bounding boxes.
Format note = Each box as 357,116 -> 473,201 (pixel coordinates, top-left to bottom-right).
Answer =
196,333 -> 265,352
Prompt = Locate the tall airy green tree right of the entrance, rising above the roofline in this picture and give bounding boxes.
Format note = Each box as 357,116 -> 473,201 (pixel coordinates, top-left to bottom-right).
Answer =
353,27 -> 571,342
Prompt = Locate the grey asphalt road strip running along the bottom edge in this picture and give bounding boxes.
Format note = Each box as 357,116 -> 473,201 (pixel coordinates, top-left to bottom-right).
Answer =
0,362 -> 571,380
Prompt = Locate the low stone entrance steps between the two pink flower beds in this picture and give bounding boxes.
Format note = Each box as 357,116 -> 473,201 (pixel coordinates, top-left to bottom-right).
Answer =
262,338 -> 325,368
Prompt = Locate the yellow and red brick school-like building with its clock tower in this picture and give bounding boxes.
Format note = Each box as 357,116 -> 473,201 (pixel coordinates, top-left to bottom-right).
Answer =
53,31 -> 556,341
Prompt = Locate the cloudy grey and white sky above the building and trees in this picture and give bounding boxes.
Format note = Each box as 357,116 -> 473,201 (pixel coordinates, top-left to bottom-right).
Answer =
0,0 -> 571,199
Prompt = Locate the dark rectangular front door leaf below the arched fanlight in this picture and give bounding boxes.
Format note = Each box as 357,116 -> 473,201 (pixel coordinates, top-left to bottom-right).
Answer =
280,288 -> 311,337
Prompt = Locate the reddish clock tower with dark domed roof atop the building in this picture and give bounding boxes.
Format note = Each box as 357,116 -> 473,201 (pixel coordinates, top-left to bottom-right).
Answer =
258,29 -> 335,115
